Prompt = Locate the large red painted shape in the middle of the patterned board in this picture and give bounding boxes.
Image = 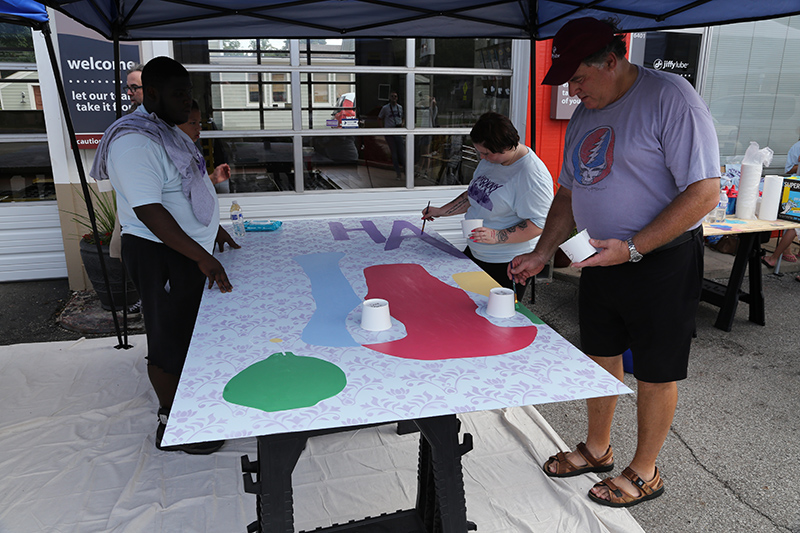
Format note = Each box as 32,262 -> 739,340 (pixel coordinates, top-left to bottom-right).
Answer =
364,264 -> 537,361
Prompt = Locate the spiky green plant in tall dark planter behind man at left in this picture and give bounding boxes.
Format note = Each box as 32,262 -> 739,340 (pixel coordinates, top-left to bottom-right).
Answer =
70,188 -> 139,310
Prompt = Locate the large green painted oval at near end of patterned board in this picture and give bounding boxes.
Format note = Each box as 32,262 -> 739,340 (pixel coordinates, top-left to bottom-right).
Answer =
222,352 -> 347,412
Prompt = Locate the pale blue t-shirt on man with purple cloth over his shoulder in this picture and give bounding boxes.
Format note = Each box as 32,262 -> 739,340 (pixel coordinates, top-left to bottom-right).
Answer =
107,111 -> 219,253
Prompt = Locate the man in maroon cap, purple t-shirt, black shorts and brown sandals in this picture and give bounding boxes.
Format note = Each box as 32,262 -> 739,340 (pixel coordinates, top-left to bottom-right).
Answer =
509,18 -> 720,507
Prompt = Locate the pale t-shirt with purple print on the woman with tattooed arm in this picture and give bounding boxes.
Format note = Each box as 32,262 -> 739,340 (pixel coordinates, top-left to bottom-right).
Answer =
465,148 -> 553,263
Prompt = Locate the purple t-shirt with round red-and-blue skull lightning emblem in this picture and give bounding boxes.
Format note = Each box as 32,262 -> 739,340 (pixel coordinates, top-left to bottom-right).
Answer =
558,67 -> 720,240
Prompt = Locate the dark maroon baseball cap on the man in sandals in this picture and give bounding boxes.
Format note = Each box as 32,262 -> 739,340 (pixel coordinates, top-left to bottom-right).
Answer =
542,17 -> 614,85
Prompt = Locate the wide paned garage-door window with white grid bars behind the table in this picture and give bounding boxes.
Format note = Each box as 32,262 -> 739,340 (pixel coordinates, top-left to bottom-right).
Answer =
174,39 -> 513,192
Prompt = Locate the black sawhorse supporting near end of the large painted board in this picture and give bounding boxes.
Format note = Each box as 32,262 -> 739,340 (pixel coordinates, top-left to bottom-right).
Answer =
242,415 -> 476,533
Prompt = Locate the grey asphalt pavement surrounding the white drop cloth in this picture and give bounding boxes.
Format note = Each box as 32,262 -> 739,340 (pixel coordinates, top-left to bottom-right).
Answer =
0,244 -> 800,533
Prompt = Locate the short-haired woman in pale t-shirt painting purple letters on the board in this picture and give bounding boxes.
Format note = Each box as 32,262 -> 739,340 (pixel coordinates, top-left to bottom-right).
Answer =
422,112 -> 553,301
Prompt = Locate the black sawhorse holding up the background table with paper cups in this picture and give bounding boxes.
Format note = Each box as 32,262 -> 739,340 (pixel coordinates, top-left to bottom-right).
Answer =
700,232 -> 769,331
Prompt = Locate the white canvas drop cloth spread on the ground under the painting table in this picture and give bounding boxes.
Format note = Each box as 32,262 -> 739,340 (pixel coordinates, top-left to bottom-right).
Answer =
0,336 -> 642,533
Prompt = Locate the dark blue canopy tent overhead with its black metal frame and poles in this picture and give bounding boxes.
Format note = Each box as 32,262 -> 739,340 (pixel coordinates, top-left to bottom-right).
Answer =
0,0 -> 800,347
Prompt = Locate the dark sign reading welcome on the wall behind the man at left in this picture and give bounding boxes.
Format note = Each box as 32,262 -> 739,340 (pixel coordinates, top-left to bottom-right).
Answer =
58,33 -> 139,149
